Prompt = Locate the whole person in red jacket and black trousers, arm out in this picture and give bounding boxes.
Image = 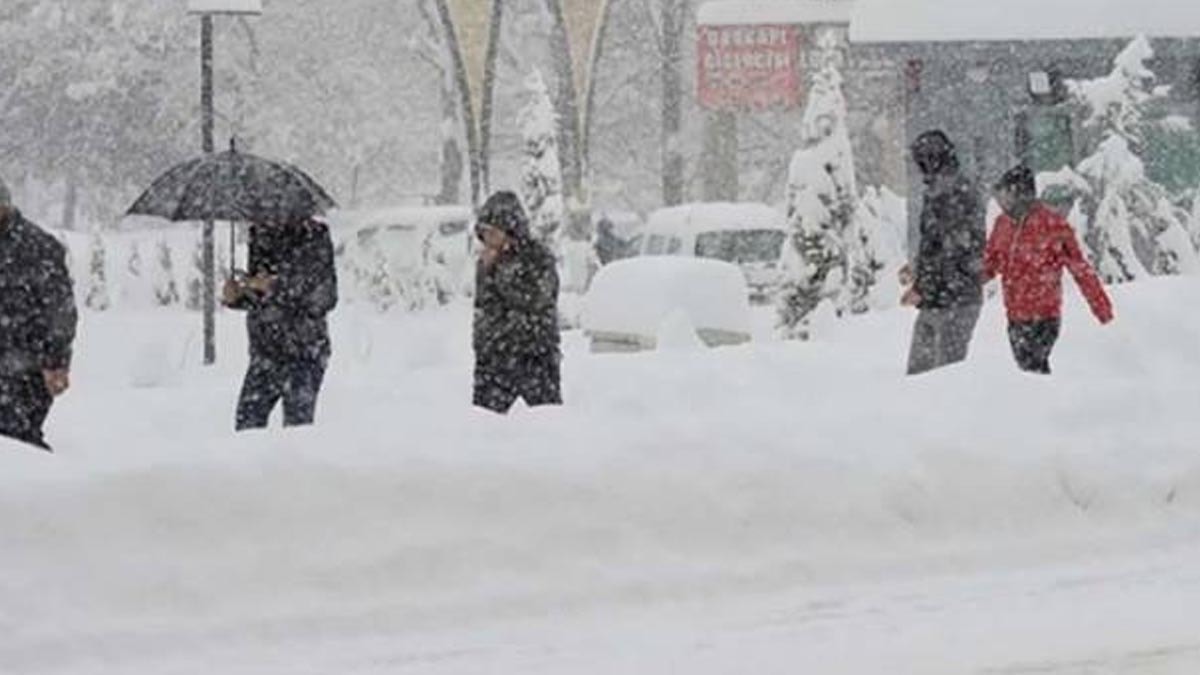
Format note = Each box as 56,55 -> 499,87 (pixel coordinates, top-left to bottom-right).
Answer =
984,166 -> 1112,375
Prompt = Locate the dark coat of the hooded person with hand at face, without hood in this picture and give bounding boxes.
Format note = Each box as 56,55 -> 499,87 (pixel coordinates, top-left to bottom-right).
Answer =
474,234 -> 559,371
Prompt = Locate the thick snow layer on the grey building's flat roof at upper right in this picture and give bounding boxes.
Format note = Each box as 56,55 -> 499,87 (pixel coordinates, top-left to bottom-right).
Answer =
850,0 -> 1200,42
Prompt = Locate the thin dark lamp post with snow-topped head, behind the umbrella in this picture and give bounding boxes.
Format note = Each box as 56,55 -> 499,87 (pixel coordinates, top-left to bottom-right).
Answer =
187,0 -> 263,365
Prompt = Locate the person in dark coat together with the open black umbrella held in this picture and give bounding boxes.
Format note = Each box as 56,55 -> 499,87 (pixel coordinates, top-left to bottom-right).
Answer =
128,139 -> 337,431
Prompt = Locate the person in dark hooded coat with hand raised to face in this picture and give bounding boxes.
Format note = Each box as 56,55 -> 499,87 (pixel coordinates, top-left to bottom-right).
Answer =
474,187 -> 563,414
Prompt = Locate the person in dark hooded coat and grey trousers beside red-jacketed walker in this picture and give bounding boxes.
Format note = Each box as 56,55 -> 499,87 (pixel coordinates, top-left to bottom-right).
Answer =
900,131 -> 988,375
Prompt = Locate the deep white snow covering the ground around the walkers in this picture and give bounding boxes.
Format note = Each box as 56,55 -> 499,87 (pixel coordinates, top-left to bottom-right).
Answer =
0,277 -> 1200,675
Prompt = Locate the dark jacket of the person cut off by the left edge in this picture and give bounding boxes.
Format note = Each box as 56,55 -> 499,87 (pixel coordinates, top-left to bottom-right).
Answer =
0,210 -> 78,376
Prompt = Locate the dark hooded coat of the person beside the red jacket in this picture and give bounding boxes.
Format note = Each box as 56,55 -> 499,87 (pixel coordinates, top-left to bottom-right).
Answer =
913,152 -> 988,310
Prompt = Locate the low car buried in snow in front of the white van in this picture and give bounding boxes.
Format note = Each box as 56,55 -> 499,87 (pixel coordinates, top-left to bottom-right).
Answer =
582,257 -> 751,352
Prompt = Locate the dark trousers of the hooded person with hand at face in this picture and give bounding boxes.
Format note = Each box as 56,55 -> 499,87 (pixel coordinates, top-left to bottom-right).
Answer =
474,354 -> 563,414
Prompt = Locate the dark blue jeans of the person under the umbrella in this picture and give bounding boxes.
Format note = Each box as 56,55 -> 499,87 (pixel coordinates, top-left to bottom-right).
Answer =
238,357 -> 326,431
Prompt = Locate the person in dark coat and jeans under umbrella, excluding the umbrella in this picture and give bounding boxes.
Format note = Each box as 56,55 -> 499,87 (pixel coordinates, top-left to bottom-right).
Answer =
223,220 -> 337,431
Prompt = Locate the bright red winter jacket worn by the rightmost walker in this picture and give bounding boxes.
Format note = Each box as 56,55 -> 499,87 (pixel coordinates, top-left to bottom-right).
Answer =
984,202 -> 1112,323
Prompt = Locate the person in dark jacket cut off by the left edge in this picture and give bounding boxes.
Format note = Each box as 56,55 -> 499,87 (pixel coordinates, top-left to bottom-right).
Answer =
0,176 -> 78,450
